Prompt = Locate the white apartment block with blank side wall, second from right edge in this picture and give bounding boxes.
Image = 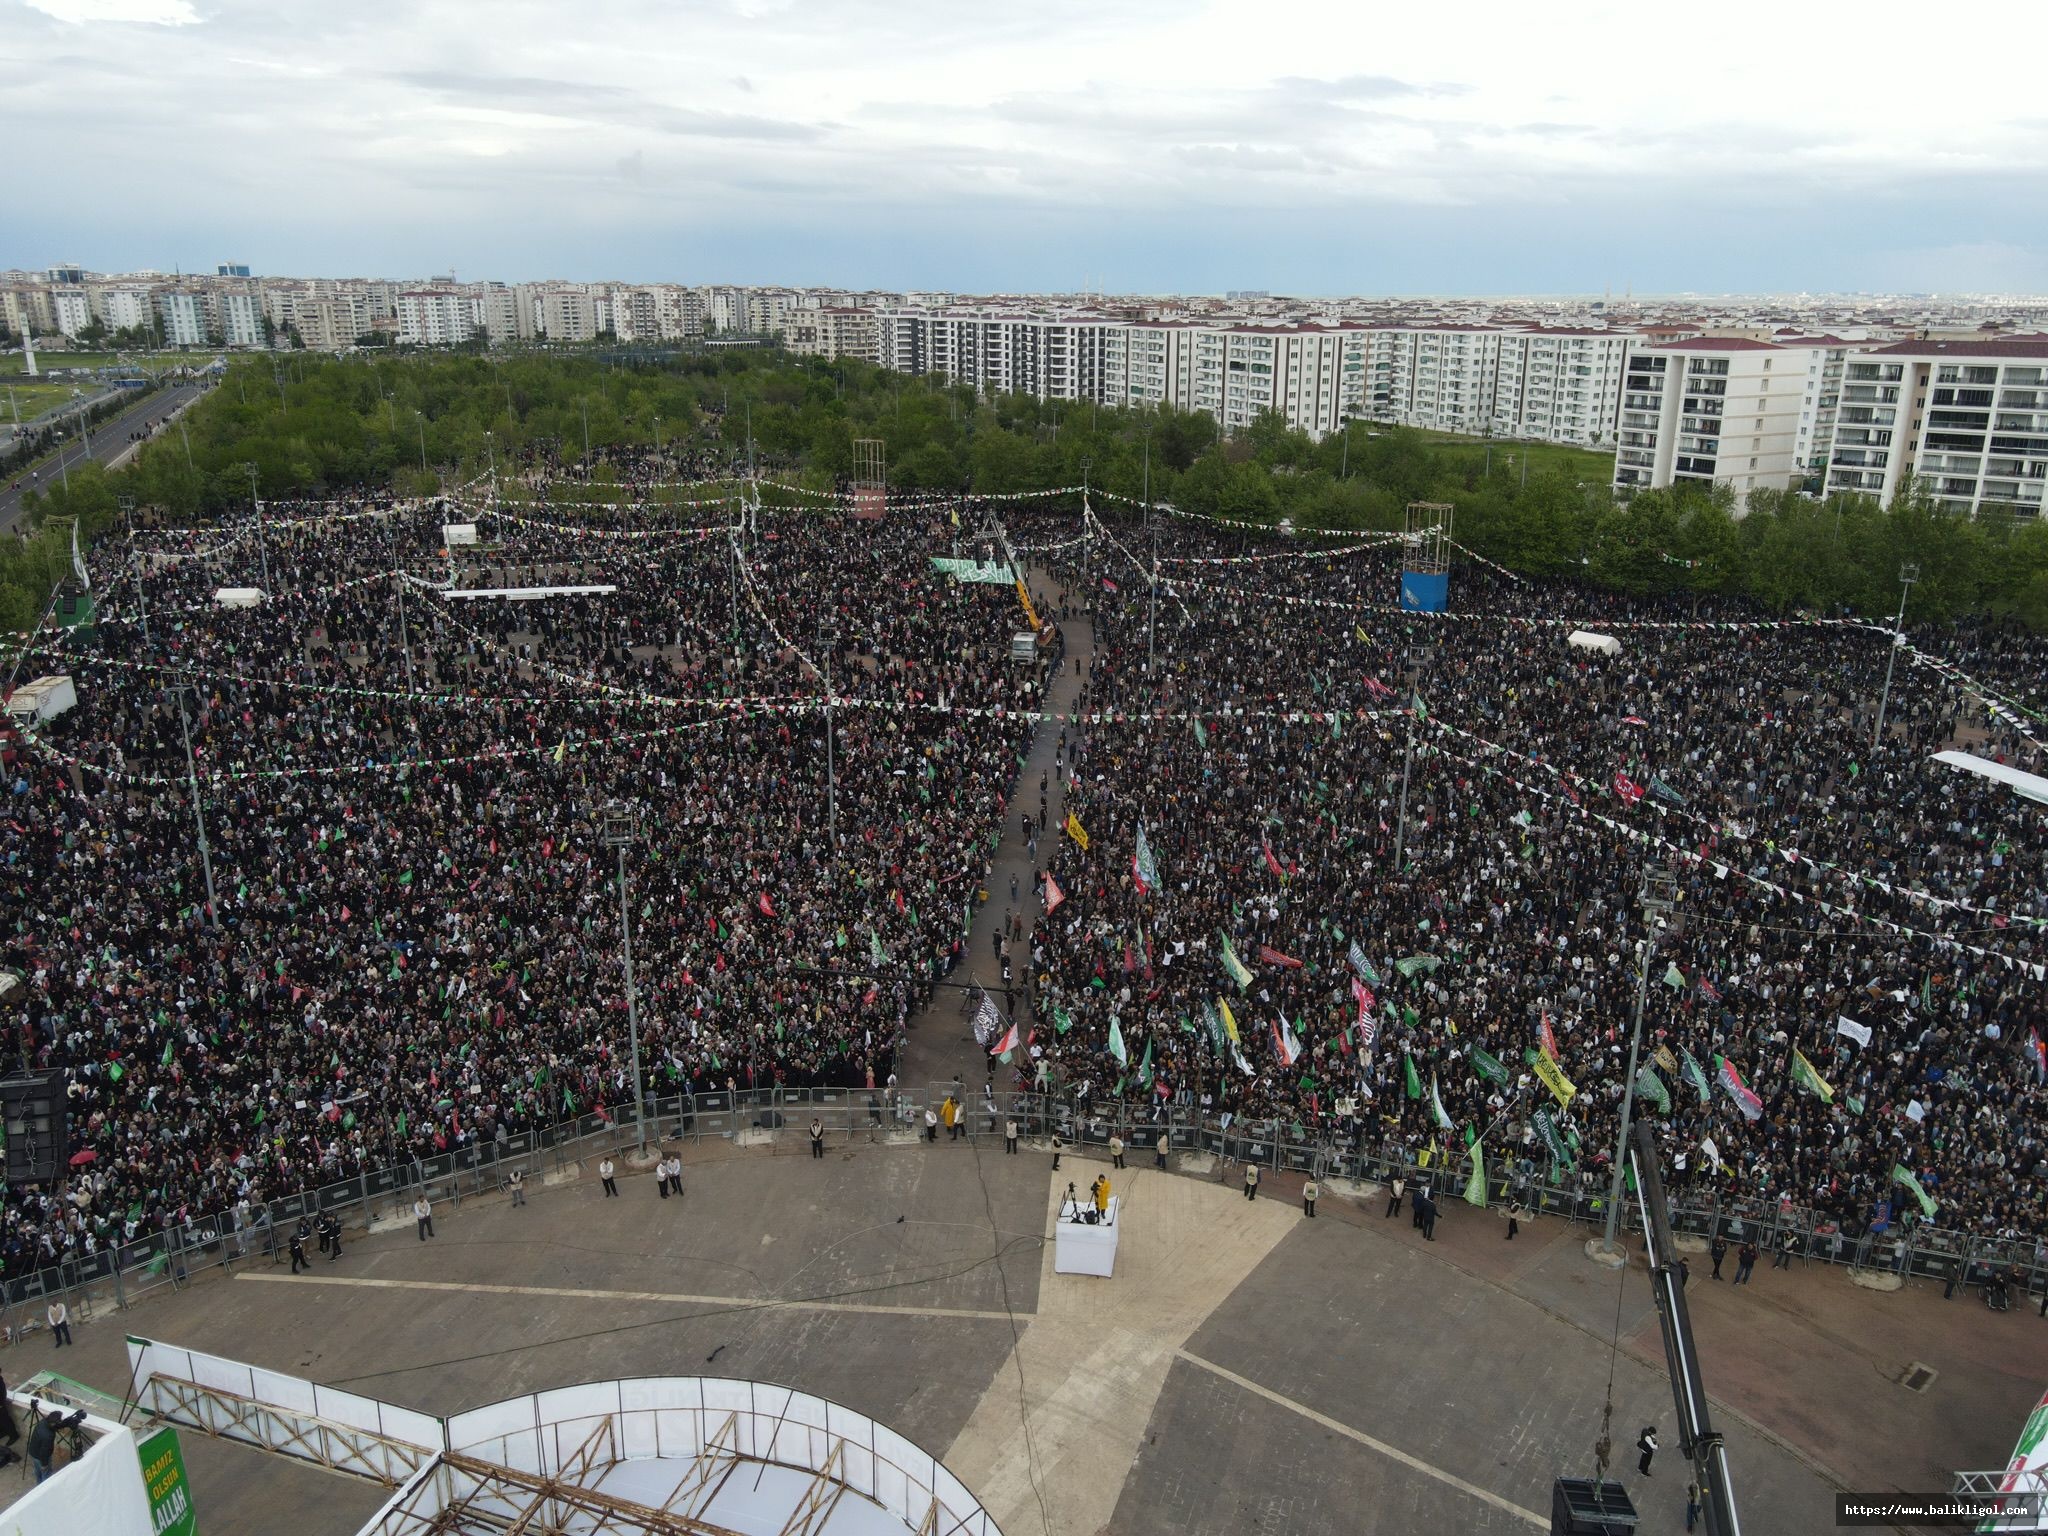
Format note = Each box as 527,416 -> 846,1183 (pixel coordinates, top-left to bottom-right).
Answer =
1614,336 -> 1819,510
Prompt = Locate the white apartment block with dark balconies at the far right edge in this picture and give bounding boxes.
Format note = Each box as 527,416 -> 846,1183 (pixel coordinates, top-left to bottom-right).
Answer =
1827,336 -> 2048,516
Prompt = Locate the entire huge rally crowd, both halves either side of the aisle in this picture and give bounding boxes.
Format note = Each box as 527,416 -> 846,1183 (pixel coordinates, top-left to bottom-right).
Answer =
0,468 -> 2048,1276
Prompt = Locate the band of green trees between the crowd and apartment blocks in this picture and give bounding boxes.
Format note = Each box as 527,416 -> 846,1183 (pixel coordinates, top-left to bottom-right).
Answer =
0,348 -> 2048,629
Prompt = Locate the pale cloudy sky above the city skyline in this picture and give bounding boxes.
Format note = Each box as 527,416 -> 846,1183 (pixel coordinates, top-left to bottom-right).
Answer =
0,0 -> 2048,295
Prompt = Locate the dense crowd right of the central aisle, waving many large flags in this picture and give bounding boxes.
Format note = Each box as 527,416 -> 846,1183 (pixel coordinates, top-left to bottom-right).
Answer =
1016,526 -> 2048,1237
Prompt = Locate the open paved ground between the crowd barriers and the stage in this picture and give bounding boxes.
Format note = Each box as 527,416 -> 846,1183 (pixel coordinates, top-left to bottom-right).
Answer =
24,1135 -> 2048,1536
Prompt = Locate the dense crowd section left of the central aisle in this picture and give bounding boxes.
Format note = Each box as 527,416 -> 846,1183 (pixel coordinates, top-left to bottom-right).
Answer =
4,481 -> 1042,1274
